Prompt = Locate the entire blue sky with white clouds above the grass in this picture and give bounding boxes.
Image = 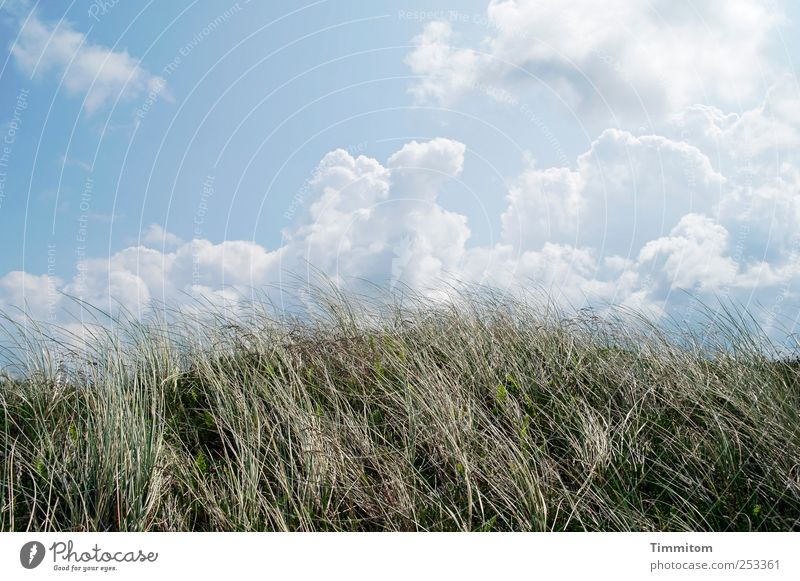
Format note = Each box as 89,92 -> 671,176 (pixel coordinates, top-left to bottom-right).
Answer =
0,0 -> 800,333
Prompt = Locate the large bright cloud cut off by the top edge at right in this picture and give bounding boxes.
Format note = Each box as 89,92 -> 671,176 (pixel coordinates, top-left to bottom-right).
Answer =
406,0 -> 783,117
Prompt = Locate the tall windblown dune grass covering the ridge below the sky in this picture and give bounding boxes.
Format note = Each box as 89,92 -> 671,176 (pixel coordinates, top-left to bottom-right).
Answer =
0,292 -> 800,531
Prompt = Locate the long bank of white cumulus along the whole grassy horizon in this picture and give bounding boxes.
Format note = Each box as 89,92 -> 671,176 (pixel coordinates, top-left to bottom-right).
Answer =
0,85 -> 800,334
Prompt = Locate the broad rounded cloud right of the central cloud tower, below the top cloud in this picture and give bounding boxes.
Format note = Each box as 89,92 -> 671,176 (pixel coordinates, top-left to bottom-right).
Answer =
503,129 -> 725,256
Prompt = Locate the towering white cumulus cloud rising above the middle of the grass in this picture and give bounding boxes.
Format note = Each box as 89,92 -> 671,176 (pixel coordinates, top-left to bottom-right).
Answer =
290,139 -> 469,286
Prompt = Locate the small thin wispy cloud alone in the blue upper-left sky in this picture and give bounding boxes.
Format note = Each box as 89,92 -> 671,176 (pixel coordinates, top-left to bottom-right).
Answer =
11,12 -> 164,114
